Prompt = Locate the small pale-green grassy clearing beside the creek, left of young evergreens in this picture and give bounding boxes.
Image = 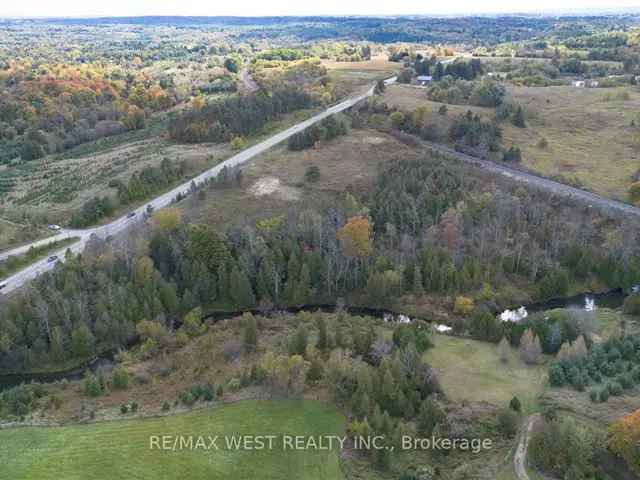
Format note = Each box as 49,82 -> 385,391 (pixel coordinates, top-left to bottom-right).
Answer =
425,335 -> 544,411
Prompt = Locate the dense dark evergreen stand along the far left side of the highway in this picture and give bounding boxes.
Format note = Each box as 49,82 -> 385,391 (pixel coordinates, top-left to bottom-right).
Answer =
169,86 -> 312,143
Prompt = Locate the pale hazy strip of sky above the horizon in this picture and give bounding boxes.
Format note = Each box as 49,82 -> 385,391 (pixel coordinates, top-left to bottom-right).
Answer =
0,0 -> 640,17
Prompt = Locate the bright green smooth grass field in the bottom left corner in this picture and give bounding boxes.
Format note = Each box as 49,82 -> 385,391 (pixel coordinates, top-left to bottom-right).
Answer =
0,400 -> 345,480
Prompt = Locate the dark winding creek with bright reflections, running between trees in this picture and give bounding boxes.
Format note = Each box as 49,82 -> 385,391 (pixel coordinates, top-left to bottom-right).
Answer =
0,289 -> 625,391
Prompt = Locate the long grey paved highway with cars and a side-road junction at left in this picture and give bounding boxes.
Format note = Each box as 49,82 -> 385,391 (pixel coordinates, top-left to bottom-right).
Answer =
0,77 -> 388,297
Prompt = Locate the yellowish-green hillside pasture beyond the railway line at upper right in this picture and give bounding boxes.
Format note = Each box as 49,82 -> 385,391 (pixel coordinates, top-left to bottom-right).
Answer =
384,85 -> 640,201
